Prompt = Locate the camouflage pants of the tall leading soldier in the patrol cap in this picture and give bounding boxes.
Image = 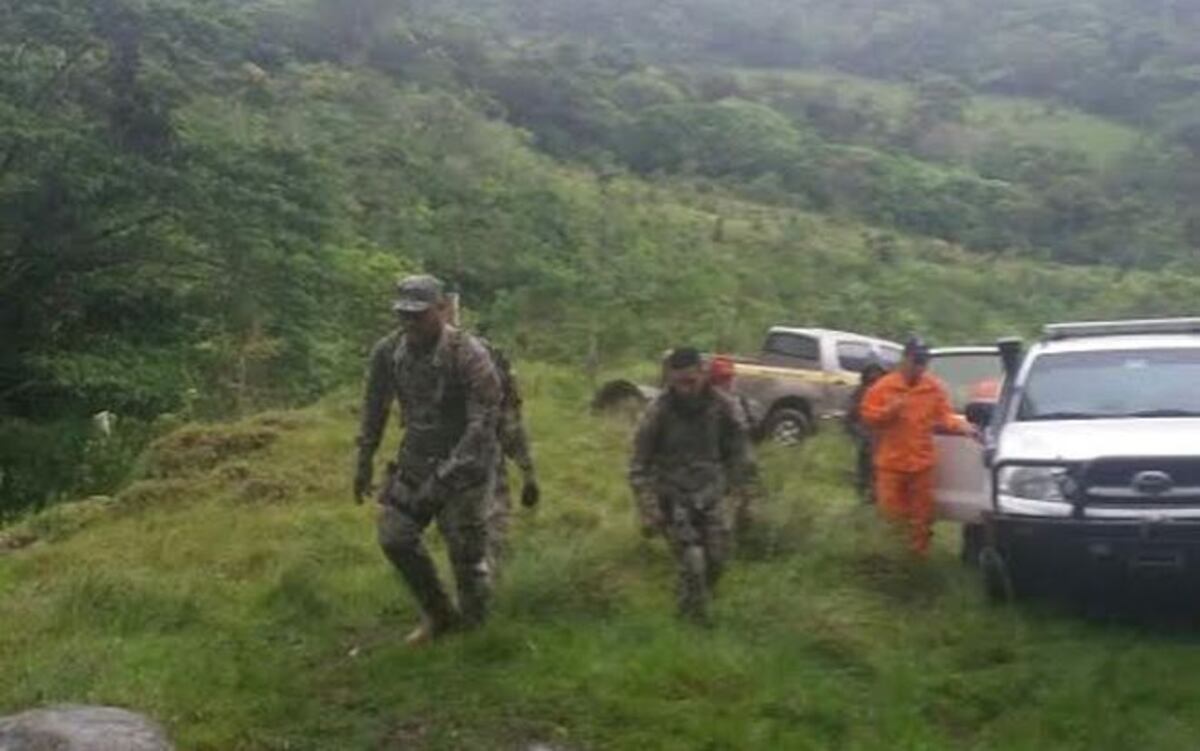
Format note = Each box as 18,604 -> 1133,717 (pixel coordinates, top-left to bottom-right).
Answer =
378,470 -> 493,630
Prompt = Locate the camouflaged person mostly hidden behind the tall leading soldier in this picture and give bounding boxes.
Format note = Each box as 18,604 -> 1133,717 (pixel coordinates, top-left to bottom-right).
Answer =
484,341 -> 541,578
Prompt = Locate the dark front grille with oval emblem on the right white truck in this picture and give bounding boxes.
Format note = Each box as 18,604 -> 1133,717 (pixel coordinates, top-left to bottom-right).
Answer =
1081,457 -> 1200,509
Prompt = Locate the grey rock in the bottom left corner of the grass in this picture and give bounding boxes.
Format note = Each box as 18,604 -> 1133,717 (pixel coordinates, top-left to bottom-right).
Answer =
0,705 -> 174,751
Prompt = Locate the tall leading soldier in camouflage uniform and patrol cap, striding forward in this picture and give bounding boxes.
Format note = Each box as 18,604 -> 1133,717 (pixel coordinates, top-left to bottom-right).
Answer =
354,276 -> 500,644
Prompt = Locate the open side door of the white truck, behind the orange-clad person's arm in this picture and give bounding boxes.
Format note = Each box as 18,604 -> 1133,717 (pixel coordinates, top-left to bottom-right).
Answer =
930,348 -> 1003,524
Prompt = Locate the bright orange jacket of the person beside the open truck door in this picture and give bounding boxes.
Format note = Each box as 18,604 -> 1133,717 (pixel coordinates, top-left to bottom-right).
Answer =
859,372 -> 968,471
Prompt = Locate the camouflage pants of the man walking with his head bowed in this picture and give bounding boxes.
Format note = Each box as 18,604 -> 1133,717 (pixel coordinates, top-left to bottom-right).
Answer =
659,488 -> 730,623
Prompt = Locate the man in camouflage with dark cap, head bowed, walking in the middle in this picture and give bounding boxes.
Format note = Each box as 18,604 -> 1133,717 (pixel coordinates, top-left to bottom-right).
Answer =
629,348 -> 750,623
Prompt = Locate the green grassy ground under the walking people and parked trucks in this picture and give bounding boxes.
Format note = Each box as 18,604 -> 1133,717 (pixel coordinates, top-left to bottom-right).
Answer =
0,367 -> 1200,750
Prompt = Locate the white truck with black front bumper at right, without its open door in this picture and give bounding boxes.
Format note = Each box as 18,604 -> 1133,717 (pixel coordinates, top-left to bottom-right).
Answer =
947,318 -> 1200,596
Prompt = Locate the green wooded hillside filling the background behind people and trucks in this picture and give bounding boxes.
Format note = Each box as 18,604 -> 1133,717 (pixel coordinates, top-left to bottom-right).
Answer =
7,0 -> 1200,517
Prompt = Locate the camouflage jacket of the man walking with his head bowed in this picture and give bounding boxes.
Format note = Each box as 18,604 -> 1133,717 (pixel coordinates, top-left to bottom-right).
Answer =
629,390 -> 754,500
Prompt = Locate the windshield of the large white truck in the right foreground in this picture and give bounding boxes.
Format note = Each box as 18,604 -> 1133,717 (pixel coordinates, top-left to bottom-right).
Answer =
1016,349 -> 1200,420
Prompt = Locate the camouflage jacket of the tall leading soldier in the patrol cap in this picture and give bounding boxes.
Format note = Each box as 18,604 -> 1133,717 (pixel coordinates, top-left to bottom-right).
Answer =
358,326 -> 502,488
